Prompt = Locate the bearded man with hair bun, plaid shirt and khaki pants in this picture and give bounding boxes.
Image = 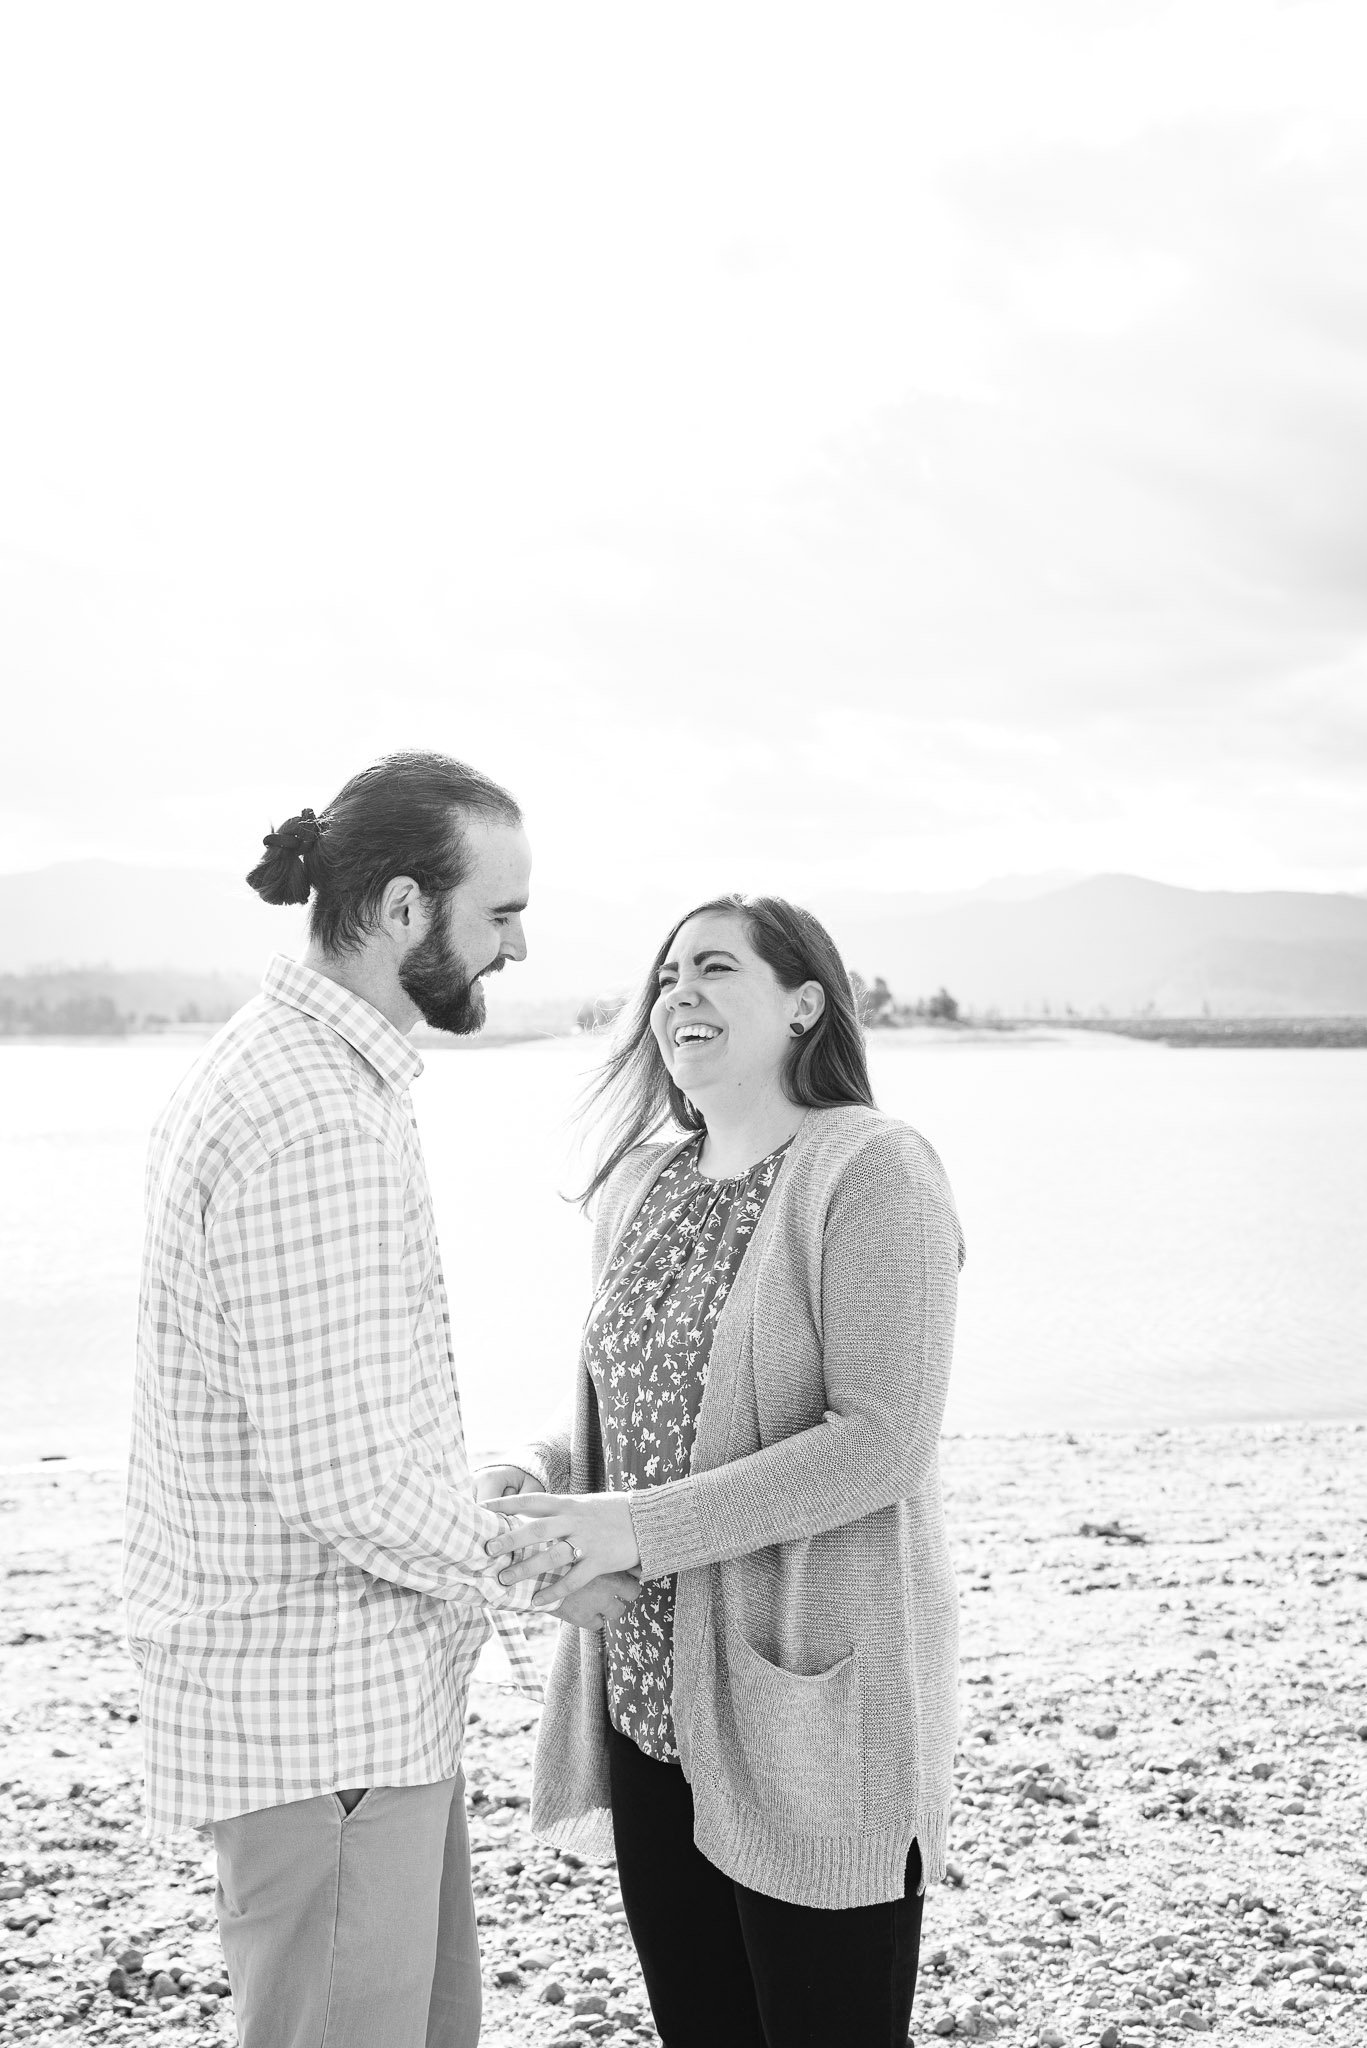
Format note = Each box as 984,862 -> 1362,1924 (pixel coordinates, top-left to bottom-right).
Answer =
125,754 -> 633,2048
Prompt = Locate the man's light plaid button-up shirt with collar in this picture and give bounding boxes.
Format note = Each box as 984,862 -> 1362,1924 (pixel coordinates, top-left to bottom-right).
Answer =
125,958 -> 535,1829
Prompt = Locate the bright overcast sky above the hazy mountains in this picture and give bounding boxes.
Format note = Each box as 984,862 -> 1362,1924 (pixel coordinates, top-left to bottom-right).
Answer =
0,0 -> 1367,897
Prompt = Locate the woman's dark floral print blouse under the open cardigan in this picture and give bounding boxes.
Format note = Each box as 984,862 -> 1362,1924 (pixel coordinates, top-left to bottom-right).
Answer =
584,1137 -> 787,1763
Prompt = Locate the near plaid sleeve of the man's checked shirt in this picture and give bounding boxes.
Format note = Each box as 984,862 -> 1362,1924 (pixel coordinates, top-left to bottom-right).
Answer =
207,1130 -> 539,1610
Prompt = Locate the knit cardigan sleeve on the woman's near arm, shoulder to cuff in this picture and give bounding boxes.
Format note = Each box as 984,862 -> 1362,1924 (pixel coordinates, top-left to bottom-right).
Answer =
631,1128 -> 963,1579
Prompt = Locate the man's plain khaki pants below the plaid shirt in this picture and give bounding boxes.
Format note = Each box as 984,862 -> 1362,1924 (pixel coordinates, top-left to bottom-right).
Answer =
213,1774 -> 480,2048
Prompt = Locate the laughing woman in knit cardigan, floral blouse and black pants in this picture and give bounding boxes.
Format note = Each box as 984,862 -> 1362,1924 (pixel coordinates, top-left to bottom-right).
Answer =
486,897 -> 963,2048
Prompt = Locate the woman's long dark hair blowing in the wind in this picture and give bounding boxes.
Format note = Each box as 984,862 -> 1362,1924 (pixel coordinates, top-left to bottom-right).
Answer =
576,895 -> 873,1206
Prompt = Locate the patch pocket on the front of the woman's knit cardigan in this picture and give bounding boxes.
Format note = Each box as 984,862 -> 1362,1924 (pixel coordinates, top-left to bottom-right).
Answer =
719,1622 -> 865,1835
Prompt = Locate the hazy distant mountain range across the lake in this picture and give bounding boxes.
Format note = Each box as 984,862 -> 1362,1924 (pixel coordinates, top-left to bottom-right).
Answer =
0,860 -> 1367,1026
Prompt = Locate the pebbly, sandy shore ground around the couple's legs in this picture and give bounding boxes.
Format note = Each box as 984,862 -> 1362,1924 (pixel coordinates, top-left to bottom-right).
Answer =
0,1425 -> 1367,2048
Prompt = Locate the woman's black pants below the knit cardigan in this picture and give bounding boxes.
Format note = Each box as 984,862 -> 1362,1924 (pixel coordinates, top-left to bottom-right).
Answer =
609,1729 -> 922,2048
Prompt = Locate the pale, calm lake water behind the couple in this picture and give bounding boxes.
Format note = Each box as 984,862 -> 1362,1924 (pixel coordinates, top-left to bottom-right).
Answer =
0,1036 -> 1367,1462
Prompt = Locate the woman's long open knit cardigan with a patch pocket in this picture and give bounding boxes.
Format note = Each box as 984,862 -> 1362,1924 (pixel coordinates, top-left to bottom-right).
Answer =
516,1108 -> 963,1909
